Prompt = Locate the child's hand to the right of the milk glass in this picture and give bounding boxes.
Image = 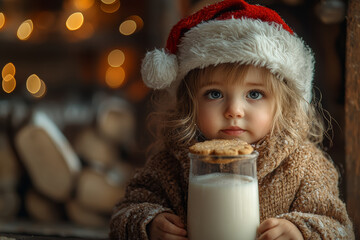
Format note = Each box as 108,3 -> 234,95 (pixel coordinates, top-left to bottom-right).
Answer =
257,218 -> 304,240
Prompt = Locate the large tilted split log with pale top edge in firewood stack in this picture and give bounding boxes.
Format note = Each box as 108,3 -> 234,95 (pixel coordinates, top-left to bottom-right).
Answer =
15,112 -> 81,202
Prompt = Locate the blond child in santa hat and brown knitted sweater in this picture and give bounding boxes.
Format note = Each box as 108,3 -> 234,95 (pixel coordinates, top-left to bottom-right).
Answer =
110,0 -> 354,240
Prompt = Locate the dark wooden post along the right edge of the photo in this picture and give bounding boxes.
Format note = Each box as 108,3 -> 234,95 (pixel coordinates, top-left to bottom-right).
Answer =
345,0 -> 360,239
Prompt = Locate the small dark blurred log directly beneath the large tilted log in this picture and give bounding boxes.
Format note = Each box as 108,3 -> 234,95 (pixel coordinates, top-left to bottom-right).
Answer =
25,189 -> 64,223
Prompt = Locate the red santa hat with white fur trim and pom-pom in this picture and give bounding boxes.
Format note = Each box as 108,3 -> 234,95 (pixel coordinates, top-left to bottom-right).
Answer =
141,0 -> 314,102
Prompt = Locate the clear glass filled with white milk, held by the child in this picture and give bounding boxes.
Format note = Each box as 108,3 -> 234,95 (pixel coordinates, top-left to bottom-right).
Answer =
187,151 -> 260,240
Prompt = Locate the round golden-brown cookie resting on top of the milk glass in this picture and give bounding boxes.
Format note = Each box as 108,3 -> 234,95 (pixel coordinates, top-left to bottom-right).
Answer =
189,139 -> 254,156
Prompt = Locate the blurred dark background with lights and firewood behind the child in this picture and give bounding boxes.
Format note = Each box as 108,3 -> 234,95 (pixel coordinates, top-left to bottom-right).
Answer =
0,0 -> 347,238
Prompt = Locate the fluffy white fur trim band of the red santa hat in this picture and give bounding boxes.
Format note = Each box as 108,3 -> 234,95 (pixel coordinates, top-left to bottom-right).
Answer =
174,19 -> 314,102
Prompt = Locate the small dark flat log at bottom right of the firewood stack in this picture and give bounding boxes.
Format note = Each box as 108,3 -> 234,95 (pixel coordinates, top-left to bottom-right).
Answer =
66,200 -> 109,227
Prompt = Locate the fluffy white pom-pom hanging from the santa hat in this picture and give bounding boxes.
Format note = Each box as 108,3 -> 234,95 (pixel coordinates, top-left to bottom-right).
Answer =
141,49 -> 178,89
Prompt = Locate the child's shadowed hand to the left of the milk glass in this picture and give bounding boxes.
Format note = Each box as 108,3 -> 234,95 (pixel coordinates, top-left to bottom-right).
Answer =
147,213 -> 187,240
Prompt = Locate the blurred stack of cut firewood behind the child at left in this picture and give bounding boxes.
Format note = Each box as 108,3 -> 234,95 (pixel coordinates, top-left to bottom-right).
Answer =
0,97 -> 135,227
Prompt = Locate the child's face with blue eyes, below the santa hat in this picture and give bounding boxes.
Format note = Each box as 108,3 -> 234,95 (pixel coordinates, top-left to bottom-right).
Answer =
196,67 -> 275,143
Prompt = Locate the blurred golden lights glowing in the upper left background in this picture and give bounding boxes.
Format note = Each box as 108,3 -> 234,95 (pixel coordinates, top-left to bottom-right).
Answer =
0,0 -> 144,98
